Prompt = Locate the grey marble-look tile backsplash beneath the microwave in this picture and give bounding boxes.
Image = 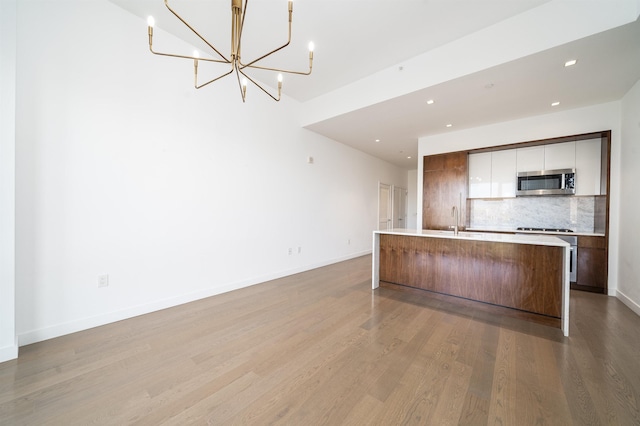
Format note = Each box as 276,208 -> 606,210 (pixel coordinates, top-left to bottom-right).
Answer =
470,196 -> 596,233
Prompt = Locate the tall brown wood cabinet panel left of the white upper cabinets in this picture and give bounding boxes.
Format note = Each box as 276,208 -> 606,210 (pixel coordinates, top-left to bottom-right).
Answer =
422,151 -> 467,229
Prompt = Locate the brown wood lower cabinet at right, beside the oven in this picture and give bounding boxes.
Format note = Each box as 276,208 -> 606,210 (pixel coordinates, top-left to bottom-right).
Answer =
574,236 -> 607,293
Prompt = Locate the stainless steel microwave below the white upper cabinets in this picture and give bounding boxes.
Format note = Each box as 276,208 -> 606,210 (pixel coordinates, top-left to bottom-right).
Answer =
516,169 -> 576,196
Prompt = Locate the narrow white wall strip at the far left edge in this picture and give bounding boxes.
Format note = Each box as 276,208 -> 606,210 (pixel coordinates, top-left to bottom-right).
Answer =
0,0 -> 18,362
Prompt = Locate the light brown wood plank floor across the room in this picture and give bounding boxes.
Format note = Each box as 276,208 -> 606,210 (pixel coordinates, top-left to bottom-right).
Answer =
0,256 -> 640,425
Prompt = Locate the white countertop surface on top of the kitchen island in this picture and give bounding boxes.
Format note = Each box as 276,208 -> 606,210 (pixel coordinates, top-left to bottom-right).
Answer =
374,228 -> 569,247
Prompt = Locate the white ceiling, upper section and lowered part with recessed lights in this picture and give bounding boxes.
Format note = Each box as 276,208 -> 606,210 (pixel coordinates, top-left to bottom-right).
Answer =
110,0 -> 640,169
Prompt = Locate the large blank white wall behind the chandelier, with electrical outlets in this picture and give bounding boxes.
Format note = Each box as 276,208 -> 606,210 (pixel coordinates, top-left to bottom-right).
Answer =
16,0 -> 407,345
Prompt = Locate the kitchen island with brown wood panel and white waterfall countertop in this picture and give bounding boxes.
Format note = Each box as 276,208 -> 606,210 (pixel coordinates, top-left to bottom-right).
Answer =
372,229 -> 569,336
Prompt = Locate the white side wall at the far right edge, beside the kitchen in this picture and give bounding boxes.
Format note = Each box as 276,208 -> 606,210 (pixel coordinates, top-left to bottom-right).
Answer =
617,82 -> 640,315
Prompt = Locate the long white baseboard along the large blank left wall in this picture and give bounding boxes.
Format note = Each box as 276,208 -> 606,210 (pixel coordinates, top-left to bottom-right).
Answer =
18,250 -> 371,348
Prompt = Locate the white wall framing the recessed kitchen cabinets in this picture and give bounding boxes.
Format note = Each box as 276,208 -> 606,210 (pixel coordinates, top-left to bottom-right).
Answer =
418,102 -> 628,295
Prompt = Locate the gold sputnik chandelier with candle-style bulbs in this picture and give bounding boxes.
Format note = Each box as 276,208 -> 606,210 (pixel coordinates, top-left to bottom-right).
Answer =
148,0 -> 313,102
